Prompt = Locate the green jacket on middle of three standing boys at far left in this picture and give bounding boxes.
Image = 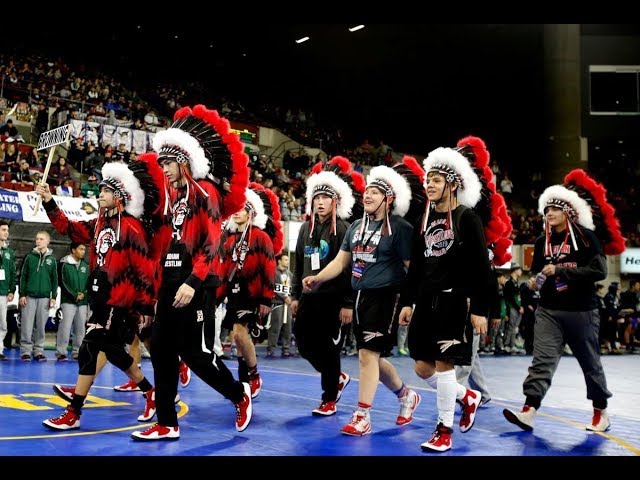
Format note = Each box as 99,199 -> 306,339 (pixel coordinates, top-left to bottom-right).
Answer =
20,248 -> 58,299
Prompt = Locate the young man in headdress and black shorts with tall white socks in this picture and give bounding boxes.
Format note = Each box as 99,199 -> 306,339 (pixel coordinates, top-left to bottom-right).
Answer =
400,141 -> 494,452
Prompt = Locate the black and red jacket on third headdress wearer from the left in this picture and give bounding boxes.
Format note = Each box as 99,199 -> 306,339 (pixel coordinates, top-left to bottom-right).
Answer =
216,227 -> 276,307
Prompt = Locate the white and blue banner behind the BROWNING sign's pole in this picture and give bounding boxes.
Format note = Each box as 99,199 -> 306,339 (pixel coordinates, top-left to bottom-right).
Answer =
0,189 -> 98,223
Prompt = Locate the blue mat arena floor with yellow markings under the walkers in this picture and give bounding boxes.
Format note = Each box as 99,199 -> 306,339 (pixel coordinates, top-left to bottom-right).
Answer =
0,347 -> 640,458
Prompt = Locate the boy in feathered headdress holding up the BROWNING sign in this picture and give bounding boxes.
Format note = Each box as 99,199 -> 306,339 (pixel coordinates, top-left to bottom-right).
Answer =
36,156 -> 161,430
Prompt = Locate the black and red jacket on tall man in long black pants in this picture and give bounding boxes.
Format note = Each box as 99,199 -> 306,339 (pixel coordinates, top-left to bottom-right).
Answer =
162,180 -> 222,290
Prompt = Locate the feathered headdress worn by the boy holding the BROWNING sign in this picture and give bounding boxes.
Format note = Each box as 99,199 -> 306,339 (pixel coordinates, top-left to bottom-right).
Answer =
96,154 -> 165,242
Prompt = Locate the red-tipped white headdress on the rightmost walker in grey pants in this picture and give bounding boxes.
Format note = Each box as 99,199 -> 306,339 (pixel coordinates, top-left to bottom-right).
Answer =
538,169 -> 625,255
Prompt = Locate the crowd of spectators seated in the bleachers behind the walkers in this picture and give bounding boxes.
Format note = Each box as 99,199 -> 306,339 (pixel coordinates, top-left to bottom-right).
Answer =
0,50 -> 640,246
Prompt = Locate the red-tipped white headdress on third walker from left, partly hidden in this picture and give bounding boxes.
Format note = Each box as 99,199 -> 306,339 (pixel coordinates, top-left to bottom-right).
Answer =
227,182 -> 284,255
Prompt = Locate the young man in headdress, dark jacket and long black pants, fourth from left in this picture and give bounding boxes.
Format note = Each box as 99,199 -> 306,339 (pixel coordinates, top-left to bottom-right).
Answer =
291,157 -> 365,416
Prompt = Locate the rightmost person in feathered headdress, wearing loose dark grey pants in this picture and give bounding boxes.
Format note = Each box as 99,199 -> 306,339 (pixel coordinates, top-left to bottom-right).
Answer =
503,169 -> 624,432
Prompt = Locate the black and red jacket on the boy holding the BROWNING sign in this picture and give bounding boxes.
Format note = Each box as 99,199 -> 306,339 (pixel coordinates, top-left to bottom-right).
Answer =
44,199 -> 158,315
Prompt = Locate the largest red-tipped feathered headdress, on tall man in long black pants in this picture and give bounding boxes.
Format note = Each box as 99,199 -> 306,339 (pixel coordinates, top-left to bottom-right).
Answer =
153,105 -> 249,219
